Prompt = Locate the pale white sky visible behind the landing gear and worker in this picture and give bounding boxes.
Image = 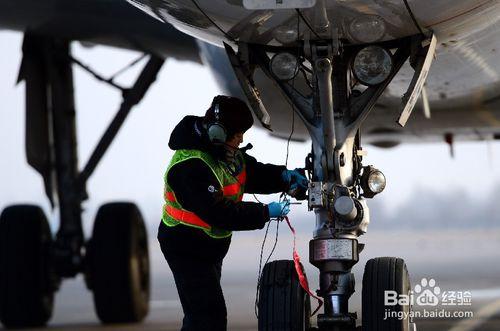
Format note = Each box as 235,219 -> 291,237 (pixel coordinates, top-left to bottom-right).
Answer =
0,31 -> 500,235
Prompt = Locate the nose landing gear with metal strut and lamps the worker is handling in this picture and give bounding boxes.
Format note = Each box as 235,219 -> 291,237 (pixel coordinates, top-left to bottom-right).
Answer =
226,29 -> 436,331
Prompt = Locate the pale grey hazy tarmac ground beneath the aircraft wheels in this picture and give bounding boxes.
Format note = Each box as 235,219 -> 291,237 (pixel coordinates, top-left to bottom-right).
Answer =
0,227 -> 500,331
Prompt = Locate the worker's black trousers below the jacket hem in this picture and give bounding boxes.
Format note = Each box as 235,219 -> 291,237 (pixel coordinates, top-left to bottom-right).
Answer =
158,224 -> 227,331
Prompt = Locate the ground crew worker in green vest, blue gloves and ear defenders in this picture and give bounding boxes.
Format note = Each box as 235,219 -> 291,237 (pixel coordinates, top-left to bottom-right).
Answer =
158,96 -> 307,331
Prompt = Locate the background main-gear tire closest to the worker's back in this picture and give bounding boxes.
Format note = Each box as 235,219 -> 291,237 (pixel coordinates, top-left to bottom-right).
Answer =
87,202 -> 150,323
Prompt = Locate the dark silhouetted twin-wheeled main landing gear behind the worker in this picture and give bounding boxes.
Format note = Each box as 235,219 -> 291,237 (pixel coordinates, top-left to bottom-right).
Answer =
0,33 -> 164,327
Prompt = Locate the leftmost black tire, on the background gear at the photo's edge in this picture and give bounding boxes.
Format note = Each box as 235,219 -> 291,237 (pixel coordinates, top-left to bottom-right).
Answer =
0,205 -> 54,328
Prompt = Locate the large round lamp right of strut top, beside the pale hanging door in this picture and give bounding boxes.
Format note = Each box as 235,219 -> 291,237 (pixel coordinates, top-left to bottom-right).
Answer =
353,46 -> 392,85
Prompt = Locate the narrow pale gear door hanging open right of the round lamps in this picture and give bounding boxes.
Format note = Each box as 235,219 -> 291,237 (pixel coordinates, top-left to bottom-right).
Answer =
398,34 -> 437,127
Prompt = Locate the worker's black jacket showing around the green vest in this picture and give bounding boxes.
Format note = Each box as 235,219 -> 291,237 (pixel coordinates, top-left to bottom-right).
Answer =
160,116 -> 286,258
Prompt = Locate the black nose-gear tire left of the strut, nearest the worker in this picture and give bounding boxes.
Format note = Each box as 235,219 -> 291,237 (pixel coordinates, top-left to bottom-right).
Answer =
258,260 -> 311,331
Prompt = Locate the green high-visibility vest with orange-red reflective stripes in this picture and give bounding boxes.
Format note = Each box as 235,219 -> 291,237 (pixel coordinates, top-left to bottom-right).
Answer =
163,150 -> 246,238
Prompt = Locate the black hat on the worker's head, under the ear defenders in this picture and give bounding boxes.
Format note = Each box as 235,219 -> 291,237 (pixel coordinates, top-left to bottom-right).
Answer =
204,95 -> 253,136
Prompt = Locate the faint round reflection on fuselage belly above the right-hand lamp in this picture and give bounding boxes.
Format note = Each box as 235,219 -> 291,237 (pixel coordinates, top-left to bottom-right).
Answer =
349,15 -> 385,44
